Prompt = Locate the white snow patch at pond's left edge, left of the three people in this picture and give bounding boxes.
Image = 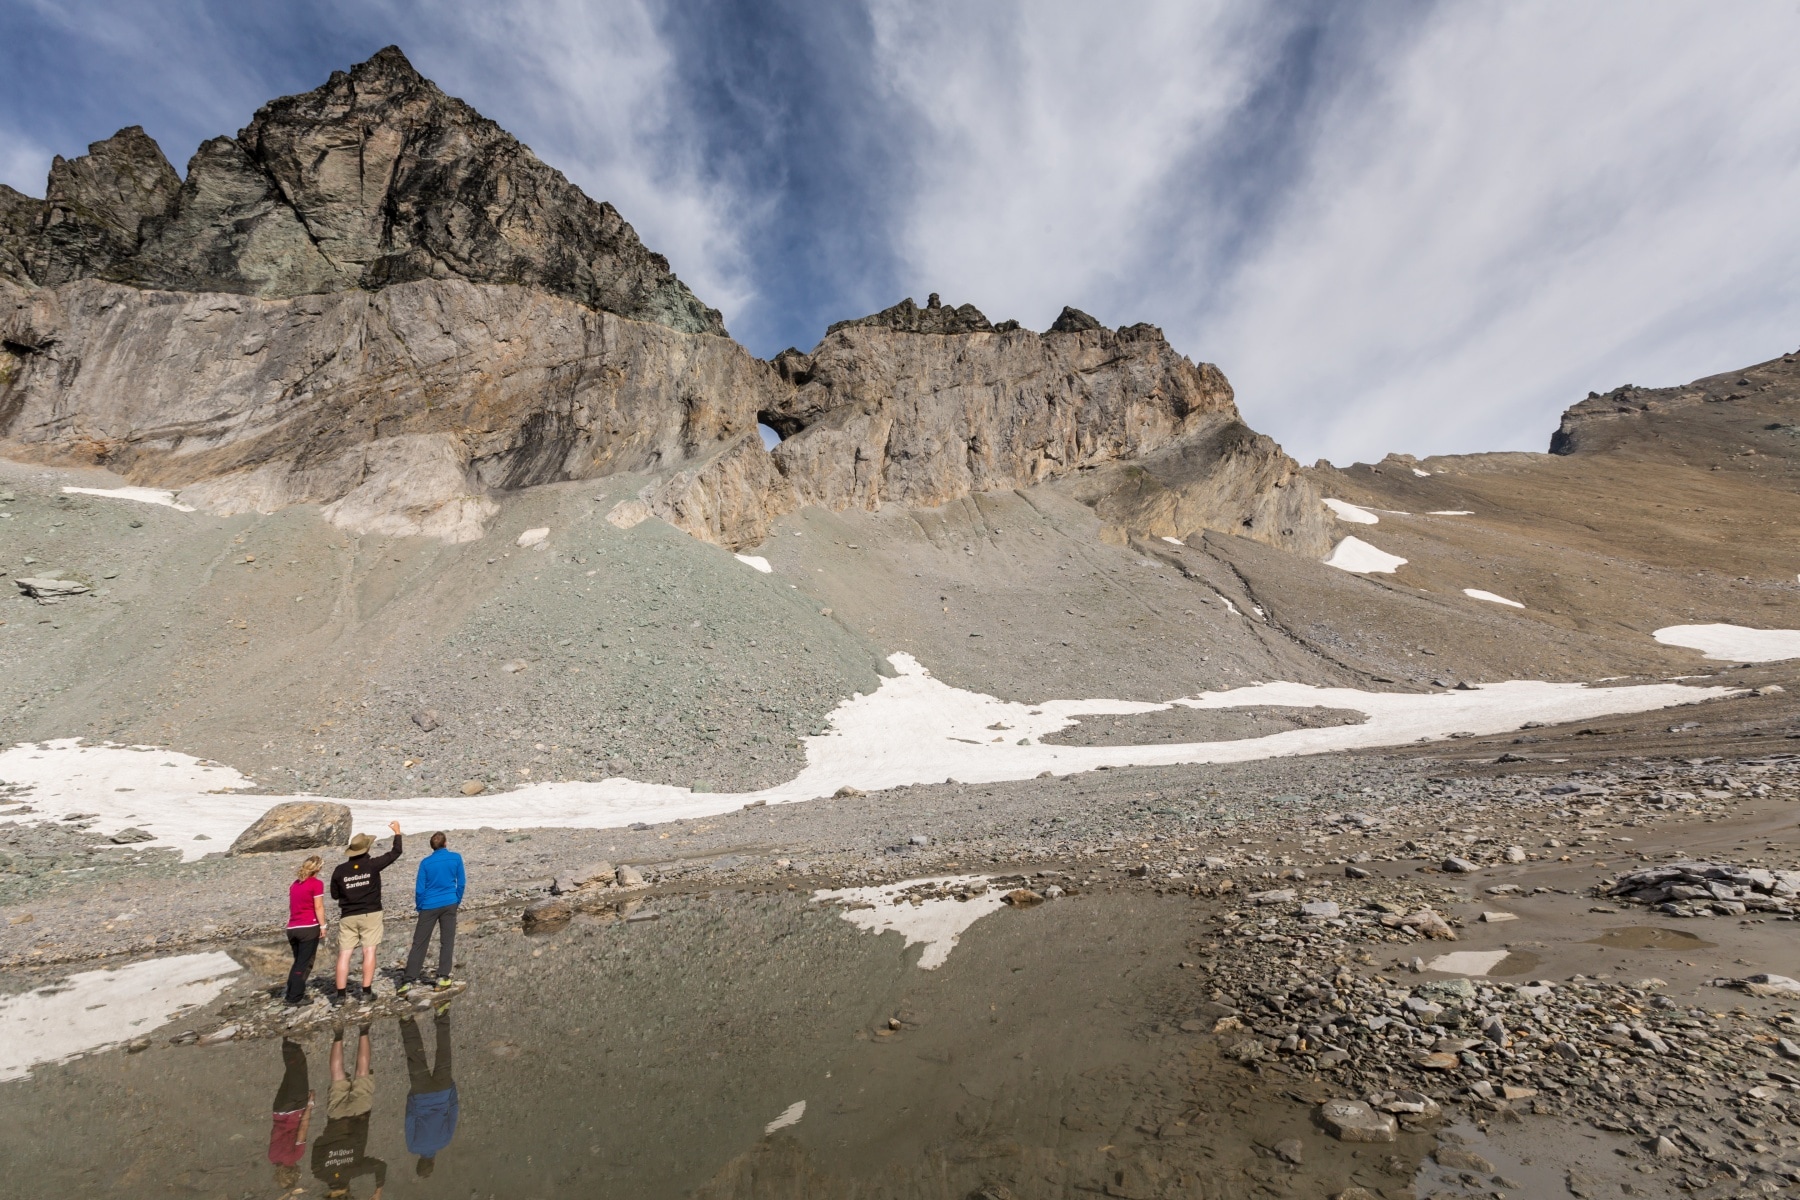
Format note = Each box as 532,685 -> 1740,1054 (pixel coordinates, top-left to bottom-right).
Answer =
0,952 -> 241,1079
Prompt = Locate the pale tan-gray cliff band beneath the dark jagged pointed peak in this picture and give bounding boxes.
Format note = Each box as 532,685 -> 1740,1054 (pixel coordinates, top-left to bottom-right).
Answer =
0,279 -> 781,540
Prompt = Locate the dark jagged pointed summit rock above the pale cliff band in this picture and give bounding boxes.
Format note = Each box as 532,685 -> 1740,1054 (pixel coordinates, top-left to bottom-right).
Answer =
0,47 -> 725,335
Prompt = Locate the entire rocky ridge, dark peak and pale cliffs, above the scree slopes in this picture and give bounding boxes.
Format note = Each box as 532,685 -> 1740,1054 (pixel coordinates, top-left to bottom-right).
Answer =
0,47 -> 1325,552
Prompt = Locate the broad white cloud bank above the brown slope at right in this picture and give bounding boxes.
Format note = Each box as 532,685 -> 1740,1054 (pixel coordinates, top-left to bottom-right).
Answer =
1202,4 -> 1800,461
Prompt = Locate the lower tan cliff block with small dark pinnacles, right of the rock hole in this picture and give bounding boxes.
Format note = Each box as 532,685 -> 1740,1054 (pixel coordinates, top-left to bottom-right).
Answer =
761,307 -> 1330,554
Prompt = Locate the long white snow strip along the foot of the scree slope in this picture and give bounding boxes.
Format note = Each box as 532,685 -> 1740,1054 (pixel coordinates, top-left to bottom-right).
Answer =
0,653 -> 1733,858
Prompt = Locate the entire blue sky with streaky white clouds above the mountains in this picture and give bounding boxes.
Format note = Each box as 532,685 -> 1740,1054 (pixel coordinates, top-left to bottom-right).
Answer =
0,0 -> 1800,462
